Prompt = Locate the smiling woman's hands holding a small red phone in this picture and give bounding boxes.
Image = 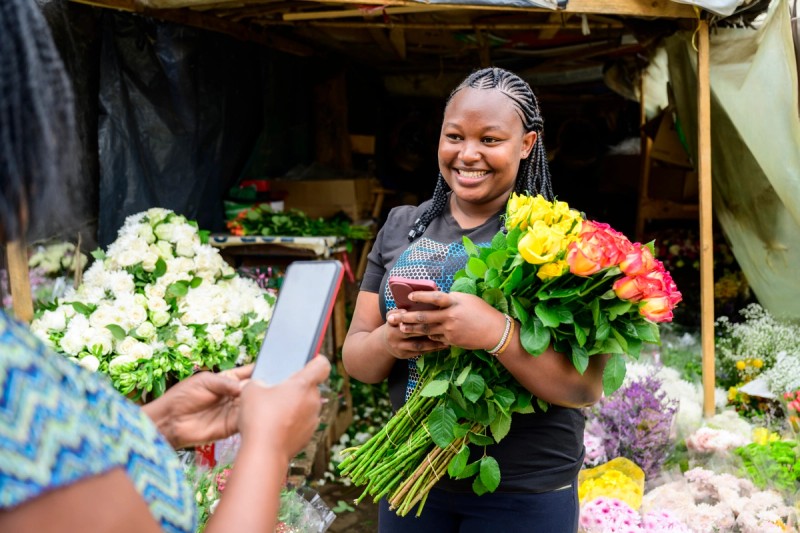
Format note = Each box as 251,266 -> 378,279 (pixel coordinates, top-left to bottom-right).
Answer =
386,291 -> 505,352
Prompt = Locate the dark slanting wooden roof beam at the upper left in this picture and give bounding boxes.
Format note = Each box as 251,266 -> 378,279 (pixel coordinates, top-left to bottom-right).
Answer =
70,0 -> 314,57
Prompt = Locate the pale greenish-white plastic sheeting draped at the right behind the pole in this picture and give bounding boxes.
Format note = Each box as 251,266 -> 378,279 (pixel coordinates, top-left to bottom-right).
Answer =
666,0 -> 800,318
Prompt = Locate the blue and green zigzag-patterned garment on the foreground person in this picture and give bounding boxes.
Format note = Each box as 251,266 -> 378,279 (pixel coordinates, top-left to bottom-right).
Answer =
0,312 -> 196,532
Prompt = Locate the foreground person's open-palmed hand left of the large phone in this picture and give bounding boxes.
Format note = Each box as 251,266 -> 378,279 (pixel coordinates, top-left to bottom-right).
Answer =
142,365 -> 253,449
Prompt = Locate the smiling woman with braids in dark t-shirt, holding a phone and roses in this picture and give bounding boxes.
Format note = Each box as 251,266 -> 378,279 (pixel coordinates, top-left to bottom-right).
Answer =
343,68 -> 606,533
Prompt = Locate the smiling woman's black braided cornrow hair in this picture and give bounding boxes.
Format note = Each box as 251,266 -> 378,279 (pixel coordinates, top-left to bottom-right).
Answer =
408,67 -> 553,241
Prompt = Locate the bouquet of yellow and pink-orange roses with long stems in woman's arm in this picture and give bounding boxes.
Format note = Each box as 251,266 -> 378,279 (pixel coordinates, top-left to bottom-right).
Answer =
340,194 -> 681,516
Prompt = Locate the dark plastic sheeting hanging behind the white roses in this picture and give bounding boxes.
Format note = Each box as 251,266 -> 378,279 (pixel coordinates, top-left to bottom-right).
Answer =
98,13 -> 262,246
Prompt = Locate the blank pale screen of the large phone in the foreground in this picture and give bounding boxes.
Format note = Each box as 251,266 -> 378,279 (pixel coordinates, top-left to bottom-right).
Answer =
253,261 -> 342,385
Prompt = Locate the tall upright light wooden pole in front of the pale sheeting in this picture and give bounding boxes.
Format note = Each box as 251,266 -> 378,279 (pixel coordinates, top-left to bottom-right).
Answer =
697,20 -> 715,417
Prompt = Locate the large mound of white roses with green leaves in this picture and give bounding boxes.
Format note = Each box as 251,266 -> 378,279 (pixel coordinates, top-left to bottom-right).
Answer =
31,208 -> 273,399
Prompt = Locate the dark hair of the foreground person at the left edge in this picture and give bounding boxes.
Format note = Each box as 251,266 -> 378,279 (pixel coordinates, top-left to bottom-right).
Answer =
0,0 -> 79,241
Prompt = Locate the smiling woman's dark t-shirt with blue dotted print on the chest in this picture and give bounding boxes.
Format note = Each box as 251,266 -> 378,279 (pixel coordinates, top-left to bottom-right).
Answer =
361,197 -> 584,492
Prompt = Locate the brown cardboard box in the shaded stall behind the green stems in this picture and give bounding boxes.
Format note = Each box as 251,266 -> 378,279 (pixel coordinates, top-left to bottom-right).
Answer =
270,178 -> 379,221
